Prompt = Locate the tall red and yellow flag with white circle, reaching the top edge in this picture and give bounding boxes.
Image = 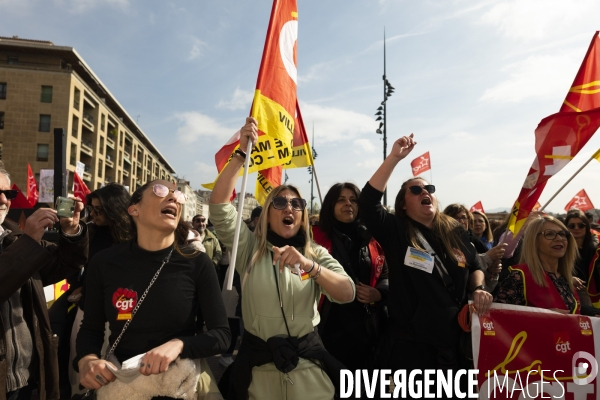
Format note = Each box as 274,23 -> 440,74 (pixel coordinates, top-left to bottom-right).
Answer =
202,0 -> 298,200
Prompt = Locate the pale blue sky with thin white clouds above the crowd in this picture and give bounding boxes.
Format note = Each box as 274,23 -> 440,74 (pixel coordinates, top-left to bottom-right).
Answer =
0,0 -> 600,211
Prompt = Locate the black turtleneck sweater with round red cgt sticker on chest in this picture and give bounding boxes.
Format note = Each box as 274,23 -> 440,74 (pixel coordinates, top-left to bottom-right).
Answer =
75,241 -> 230,364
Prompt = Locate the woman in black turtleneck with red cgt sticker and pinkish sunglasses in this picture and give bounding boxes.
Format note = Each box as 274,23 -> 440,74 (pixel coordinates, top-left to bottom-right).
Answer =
76,180 -> 230,399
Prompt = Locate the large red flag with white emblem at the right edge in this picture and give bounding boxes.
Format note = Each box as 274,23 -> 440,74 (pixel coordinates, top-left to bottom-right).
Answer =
508,32 -> 600,235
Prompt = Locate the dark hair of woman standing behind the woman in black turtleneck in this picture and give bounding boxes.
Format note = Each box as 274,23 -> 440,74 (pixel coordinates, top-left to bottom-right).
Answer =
85,182 -> 132,243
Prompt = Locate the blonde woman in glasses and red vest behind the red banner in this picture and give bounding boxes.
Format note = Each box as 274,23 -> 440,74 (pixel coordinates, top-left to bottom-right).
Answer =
494,215 -> 600,315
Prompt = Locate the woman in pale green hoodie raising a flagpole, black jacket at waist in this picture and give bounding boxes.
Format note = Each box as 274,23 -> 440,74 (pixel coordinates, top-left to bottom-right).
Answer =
210,118 -> 354,400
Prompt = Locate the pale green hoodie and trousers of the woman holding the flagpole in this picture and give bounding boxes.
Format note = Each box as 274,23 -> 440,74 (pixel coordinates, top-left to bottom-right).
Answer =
210,204 -> 356,400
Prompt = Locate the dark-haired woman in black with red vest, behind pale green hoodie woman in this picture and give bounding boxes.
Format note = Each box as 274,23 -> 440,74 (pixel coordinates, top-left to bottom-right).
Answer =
313,182 -> 389,370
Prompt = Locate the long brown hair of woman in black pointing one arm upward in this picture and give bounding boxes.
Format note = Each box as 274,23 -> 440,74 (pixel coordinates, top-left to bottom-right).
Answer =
394,176 -> 463,261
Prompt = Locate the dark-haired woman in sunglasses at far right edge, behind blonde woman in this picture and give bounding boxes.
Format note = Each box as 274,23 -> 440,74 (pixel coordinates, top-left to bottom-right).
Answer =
565,210 -> 600,308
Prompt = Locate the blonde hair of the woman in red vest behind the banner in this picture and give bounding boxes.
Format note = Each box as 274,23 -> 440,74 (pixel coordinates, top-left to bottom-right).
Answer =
519,215 -> 579,292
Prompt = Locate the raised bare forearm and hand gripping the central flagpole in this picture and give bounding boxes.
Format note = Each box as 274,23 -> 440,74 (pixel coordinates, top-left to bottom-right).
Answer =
209,117 -> 258,204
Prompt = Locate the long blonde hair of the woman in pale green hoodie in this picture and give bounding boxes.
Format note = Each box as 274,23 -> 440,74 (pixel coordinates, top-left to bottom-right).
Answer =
250,185 -> 316,265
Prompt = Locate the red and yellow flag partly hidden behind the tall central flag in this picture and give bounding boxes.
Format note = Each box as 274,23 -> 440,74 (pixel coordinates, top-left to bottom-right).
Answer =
255,102 -> 314,205
